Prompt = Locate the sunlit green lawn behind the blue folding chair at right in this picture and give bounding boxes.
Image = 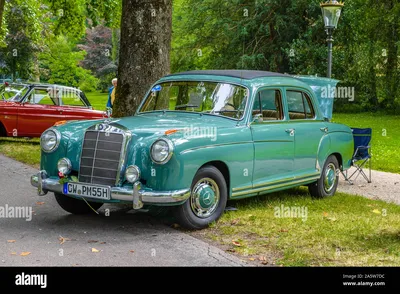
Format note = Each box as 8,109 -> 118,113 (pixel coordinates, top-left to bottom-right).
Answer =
333,113 -> 400,173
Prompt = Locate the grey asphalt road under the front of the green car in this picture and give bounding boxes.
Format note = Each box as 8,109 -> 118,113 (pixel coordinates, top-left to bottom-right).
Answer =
0,155 -> 245,266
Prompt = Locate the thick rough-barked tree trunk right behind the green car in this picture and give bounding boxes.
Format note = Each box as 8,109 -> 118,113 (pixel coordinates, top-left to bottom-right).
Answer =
113,0 -> 172,117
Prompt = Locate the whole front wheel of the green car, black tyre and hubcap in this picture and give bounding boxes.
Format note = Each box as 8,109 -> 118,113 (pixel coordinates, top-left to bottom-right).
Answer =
175,166 -> 228,229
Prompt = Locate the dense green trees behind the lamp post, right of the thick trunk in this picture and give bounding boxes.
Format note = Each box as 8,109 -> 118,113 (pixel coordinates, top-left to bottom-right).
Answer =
171,0 -> 400,114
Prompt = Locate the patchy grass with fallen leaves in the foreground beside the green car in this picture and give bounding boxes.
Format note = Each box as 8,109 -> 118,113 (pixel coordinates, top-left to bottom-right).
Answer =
193,188 -> 400,266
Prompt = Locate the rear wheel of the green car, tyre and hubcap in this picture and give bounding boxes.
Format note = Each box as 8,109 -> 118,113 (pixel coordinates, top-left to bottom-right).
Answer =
308,155 -> 339,198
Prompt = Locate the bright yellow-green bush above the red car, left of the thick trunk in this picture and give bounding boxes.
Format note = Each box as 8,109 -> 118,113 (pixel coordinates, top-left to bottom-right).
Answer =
39,36 -> 98,91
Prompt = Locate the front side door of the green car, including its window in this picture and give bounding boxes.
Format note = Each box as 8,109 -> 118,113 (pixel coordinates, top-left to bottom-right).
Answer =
251,89 -> 294,188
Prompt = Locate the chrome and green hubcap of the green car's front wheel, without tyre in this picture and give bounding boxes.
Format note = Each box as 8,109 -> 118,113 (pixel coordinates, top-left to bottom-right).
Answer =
190,178 -> 220,218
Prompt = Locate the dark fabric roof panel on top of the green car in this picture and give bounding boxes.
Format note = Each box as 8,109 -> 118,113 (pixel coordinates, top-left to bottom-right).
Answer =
167,69 -> 293,80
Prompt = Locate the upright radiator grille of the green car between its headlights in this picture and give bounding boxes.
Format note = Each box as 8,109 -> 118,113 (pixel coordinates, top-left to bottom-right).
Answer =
79,130 -> 124,186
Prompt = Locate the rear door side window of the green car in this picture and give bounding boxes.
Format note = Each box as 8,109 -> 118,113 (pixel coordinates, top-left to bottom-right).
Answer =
286,91 -> 315,120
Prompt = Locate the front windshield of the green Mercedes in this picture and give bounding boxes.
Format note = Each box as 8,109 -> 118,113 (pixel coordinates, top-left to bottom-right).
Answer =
139,81 -> 248,119
